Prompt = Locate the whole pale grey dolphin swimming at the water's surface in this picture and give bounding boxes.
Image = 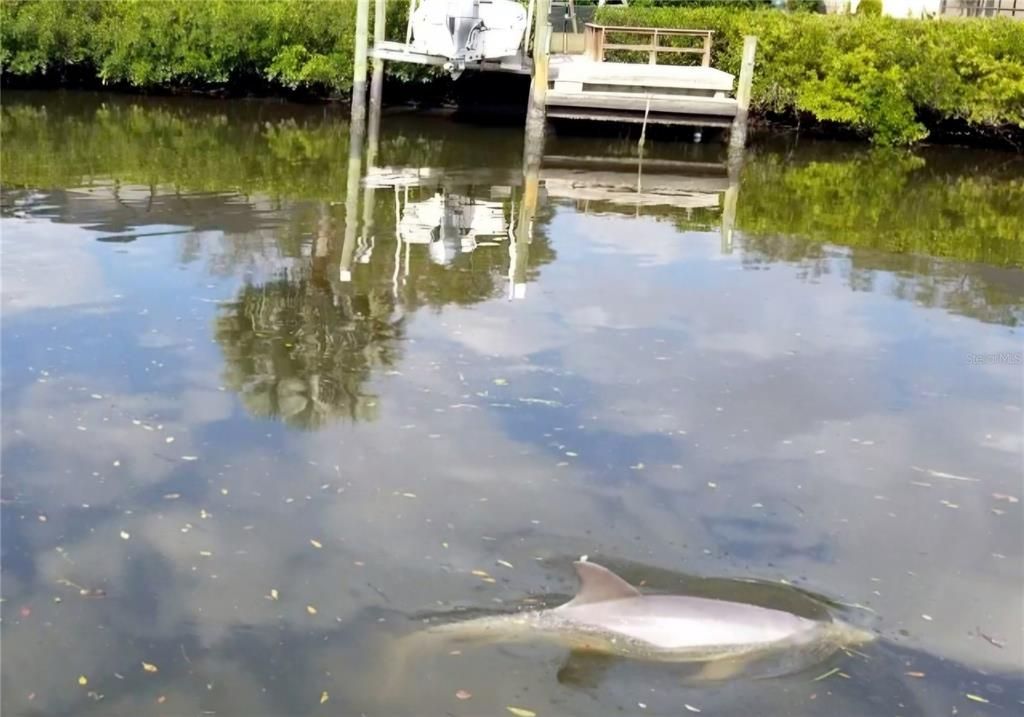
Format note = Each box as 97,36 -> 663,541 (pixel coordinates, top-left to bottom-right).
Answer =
391,556 -> 876,680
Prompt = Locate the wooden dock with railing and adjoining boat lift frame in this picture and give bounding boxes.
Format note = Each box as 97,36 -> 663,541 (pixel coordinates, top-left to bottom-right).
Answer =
360,0 -> 756,139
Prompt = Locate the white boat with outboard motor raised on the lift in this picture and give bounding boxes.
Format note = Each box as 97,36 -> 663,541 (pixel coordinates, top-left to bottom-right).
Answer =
412,0 -> 526,76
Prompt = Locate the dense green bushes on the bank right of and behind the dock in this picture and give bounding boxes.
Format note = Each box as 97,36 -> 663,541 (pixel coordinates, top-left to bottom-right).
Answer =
597,7 -> 1024,144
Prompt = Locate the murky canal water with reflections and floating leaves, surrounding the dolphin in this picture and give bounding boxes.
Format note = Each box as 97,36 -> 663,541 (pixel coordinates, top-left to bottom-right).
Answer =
0,93 -> 1024,717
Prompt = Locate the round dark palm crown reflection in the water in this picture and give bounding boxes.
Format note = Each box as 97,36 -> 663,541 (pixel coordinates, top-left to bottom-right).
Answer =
214,267 -> 403,428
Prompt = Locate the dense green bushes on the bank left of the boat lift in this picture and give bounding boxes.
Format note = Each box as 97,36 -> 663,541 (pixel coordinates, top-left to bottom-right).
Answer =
0,0 -> 421,93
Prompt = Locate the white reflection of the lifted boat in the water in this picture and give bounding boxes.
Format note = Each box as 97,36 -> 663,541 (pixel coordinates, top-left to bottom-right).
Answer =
398,189 -> 508,264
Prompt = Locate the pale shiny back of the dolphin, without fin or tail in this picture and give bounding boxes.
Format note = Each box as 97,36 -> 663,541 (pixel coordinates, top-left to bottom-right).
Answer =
558,595 -> 819,650
